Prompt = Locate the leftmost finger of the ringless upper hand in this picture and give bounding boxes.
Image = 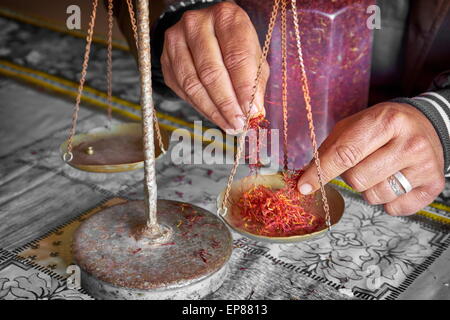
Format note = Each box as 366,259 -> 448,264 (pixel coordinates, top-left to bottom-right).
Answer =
161,29 -> 234,133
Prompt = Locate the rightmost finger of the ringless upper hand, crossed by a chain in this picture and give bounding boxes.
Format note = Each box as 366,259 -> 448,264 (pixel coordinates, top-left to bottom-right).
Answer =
213,2 -> 269,115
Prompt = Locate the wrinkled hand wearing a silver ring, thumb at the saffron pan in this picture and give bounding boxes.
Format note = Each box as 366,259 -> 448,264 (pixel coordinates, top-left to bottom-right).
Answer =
298,103 -> 445,216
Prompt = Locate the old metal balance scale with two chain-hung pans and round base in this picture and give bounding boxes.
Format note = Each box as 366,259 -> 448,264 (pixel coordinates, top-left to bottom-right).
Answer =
61,0 -> 344,300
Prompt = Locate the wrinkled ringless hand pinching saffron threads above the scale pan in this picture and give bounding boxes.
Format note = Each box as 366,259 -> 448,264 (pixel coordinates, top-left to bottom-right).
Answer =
161,2 -> 269,134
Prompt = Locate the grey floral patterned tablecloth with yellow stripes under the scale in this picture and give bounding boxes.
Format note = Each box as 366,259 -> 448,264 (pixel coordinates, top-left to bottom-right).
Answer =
0,9 -> 450,299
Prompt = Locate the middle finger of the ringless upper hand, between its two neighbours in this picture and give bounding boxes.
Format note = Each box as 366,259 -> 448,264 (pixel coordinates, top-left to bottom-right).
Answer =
182,10 -> 245,130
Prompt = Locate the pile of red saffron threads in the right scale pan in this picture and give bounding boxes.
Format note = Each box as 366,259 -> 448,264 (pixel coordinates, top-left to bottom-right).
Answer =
237,170 -> 325,237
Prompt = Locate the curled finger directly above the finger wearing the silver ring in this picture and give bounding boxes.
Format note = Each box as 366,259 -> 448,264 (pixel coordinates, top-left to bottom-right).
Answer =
341,139 -> 426,192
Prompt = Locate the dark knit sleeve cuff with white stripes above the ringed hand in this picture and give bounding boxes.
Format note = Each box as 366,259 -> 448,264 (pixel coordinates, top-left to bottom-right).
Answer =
391,89 -> 450,176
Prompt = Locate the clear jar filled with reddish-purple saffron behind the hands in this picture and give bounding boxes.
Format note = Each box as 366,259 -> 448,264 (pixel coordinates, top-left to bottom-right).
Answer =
236,0 -> 375,169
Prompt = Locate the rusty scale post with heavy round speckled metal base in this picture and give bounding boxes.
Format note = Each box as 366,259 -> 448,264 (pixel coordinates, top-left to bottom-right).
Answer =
72,0 -> 232,300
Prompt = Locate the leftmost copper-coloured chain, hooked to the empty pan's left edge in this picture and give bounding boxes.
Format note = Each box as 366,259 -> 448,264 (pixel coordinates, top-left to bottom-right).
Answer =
63,0 -> 98,162
